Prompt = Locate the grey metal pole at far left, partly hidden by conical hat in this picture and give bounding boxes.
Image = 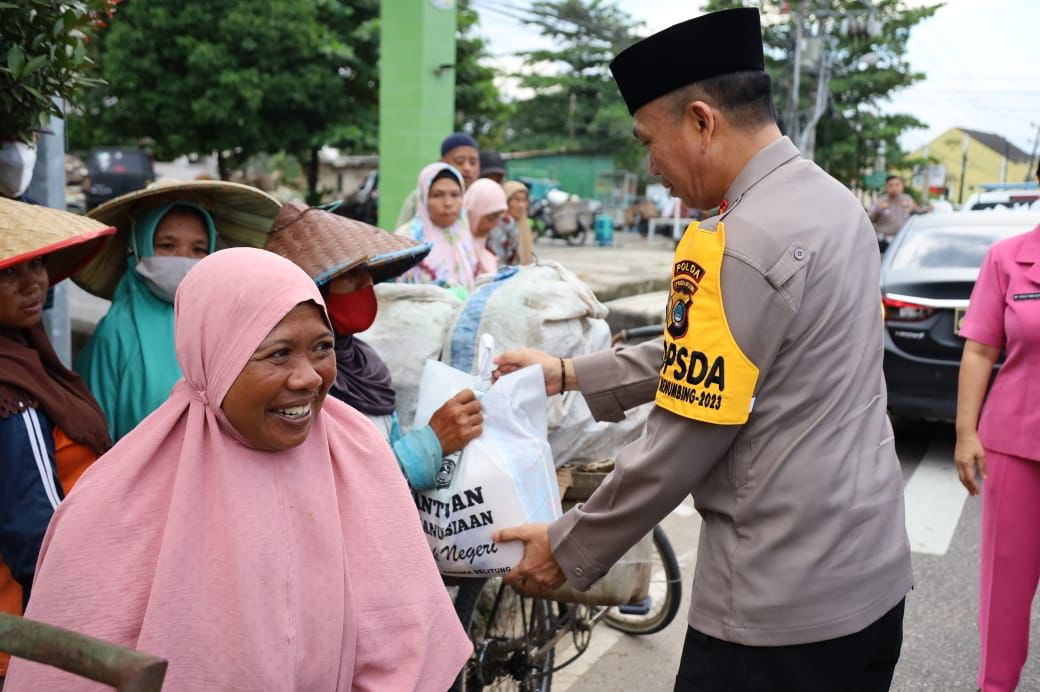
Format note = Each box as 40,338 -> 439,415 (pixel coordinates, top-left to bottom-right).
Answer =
26,104 -> 72,367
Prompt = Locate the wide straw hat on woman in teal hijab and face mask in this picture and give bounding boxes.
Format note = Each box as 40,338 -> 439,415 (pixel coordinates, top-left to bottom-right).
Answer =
73,180 -> 282,299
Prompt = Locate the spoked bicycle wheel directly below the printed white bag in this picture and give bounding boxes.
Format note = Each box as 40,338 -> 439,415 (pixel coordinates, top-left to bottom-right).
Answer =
451,579 -> 555,692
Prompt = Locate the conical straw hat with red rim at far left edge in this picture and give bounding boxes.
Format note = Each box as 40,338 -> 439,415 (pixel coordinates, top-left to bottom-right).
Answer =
0,197 -> 115,285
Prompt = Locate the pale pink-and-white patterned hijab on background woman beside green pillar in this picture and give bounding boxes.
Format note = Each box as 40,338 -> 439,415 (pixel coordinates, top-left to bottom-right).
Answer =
395,161 -> 482,290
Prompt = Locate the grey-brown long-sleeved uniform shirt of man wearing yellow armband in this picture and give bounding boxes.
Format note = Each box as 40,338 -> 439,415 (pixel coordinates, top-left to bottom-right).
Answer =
549,137 -> 912,645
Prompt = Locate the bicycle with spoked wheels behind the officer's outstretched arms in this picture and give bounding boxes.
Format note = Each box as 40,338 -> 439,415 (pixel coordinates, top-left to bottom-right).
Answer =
452,526 -> 682,692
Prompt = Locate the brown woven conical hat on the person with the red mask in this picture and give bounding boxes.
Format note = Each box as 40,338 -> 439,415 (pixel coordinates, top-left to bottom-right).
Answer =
264,202 -> 431,286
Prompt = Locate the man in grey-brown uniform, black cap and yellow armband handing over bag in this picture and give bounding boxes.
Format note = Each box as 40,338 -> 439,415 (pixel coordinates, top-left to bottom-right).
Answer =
496,8 -> 913,692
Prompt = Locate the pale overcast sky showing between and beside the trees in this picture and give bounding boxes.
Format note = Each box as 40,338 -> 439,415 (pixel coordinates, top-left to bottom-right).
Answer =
473,0 -> 1040,153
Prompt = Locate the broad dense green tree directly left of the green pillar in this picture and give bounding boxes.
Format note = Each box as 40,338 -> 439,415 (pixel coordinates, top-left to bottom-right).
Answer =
65,0 -> 378,193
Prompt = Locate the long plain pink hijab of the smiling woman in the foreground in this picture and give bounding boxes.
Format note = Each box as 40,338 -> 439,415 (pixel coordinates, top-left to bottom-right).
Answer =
5,248 -> 471,692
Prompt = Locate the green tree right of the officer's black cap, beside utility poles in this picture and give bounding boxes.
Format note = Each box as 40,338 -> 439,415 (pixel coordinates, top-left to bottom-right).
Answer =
705,0 -> 940,185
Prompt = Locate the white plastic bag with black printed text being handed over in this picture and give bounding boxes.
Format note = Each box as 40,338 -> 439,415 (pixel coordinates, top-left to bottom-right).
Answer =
415,334 -> 562,576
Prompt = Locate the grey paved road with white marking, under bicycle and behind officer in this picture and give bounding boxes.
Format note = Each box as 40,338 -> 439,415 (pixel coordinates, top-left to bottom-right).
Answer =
553,425 -> 1040,692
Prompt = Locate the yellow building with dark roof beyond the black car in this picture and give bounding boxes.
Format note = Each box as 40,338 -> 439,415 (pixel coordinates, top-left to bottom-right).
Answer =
911,127 -> 1036,204
